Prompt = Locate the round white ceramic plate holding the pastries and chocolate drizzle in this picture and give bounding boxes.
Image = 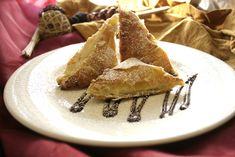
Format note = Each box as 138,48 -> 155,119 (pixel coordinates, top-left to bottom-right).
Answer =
4,42 -> 235,147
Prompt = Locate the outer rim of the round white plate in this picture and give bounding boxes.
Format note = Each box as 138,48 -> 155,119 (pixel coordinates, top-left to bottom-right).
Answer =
3,41 -> 235,147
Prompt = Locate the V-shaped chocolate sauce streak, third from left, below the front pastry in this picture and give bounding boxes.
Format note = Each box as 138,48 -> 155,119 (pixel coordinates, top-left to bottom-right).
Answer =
127,96 -> 149,122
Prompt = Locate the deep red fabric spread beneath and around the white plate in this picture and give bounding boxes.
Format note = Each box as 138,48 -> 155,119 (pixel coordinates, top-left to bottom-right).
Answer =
0,0 -> 235,157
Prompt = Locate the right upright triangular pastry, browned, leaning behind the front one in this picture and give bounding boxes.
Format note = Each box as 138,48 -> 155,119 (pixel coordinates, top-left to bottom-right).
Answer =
119,9 -> 177,75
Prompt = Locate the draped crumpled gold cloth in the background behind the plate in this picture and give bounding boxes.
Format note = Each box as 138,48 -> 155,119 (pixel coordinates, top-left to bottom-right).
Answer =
59,0 -> 235,68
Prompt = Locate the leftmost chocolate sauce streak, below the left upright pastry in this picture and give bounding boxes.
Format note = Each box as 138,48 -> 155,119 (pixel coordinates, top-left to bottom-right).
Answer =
70,92 -> 92,113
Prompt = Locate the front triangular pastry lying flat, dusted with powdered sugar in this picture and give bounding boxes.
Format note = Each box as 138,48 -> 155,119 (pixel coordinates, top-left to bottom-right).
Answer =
87,58 -> 184,99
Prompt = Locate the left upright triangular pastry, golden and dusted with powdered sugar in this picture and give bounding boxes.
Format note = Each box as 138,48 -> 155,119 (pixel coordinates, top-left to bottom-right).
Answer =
57,15 -> 118,89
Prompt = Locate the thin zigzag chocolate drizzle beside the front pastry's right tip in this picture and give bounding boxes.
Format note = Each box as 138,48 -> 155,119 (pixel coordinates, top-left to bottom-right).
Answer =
159,74 -> 198,118
